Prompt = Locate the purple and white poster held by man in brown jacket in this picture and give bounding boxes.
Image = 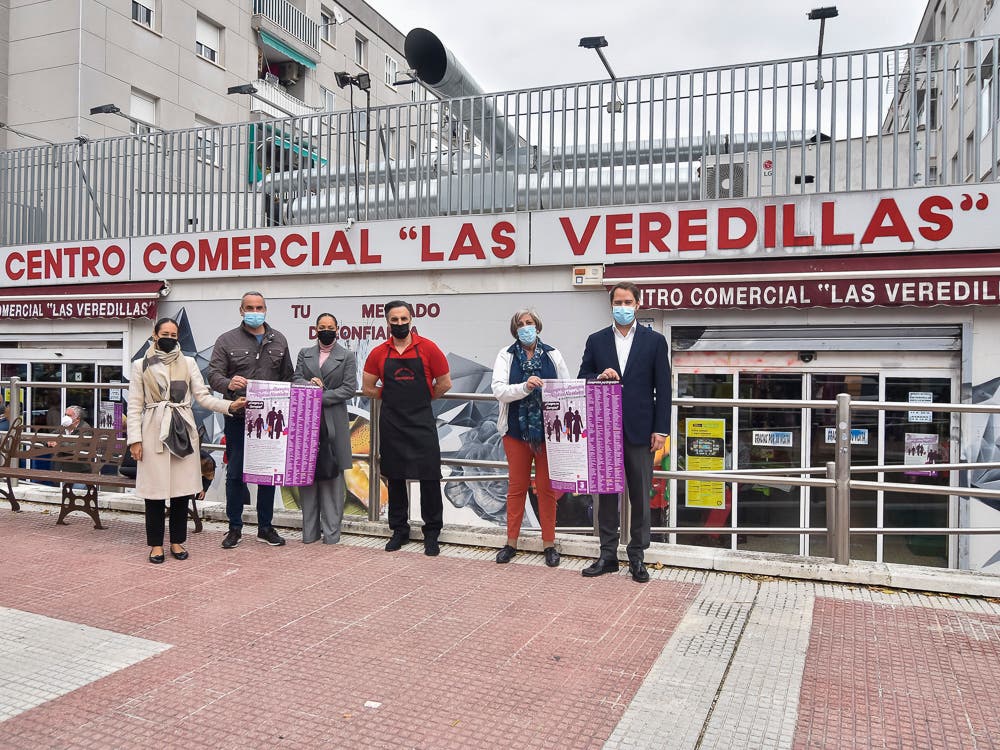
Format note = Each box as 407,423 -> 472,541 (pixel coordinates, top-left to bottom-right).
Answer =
243,380 -> 323,487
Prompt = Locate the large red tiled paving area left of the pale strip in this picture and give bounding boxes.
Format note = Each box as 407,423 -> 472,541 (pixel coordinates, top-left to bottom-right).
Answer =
0,512 -> 698,750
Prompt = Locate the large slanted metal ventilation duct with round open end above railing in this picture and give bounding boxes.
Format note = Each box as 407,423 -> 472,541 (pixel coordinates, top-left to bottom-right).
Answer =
403,29 -> 524,161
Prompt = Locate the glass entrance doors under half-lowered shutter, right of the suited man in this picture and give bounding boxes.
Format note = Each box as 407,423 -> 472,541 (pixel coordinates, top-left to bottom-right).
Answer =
668,362 -> 957,566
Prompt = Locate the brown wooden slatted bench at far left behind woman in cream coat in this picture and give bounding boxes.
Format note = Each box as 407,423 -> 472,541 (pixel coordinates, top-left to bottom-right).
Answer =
0,417 -> 202,533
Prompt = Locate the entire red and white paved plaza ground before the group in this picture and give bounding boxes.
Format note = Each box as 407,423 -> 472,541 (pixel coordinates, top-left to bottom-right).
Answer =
0,510 -> 1000,750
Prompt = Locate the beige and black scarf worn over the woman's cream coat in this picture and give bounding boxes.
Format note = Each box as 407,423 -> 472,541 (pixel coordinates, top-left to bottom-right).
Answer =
142,346 -> 194,458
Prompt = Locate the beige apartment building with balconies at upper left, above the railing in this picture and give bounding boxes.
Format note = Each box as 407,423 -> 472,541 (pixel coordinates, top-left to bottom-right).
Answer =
0,0 -> 424,149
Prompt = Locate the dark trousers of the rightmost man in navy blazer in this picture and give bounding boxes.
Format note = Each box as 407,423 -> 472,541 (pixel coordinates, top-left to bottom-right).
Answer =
597,441 -> 653,562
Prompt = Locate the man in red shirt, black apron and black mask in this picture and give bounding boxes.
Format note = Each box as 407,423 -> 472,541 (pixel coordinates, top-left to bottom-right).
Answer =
362,300 -> 451,556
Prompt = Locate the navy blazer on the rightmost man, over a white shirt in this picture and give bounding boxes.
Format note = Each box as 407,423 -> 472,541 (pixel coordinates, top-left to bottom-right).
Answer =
577,324 -> 671,445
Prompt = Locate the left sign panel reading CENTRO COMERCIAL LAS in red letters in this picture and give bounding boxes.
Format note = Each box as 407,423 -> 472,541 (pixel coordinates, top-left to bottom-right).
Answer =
0,219 -> 528,285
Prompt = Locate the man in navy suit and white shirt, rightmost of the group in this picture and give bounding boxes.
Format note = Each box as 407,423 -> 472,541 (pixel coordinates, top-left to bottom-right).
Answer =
577,281 -> 671,583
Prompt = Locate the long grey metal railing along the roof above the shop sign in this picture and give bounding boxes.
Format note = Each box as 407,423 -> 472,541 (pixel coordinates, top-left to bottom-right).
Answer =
0,34 -> 1000,245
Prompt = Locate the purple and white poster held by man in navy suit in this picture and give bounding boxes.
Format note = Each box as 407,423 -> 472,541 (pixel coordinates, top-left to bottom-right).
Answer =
542,380 -> 625,494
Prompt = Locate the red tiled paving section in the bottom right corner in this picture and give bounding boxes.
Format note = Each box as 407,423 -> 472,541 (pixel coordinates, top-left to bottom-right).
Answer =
794,598 -> 1000,750
